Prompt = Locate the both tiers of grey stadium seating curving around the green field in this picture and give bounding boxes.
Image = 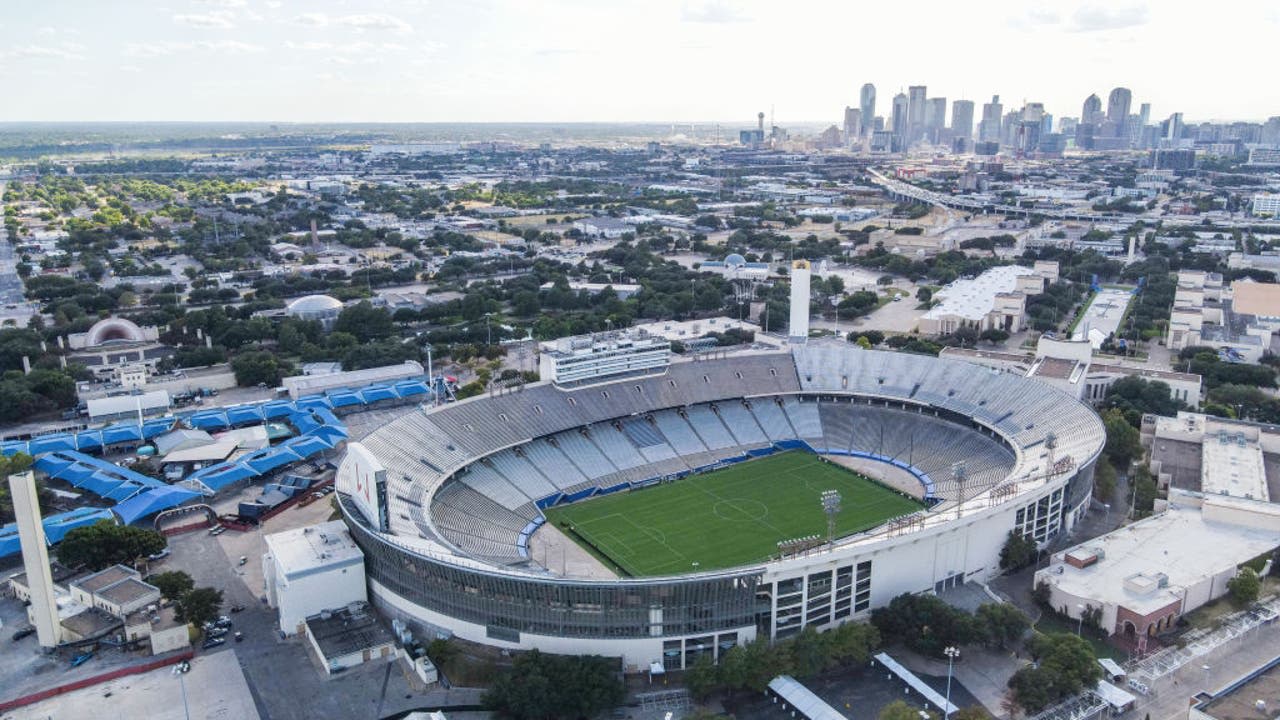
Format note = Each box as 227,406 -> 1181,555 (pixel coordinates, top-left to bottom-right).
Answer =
366,342 -> 1101,565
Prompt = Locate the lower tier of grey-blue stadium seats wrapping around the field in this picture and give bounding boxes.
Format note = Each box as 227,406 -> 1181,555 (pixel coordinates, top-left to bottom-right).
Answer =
424,397 -> 1014,564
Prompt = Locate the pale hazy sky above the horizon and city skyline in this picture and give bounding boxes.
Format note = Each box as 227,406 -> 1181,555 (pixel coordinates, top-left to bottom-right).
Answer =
0,0 -> 1280,126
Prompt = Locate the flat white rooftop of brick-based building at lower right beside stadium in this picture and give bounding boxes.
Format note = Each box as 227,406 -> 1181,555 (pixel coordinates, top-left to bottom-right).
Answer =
1041,505 -> 1280,615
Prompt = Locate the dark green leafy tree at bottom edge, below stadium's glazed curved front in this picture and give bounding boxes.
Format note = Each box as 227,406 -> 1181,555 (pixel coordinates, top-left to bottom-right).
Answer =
484,650 -> 625,720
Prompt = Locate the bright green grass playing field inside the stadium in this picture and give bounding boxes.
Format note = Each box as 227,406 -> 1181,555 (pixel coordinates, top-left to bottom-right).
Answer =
545,451 -> 923,577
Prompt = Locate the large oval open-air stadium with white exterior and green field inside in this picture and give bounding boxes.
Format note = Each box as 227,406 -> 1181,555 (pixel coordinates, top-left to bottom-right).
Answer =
337,341 -> 1105,671
